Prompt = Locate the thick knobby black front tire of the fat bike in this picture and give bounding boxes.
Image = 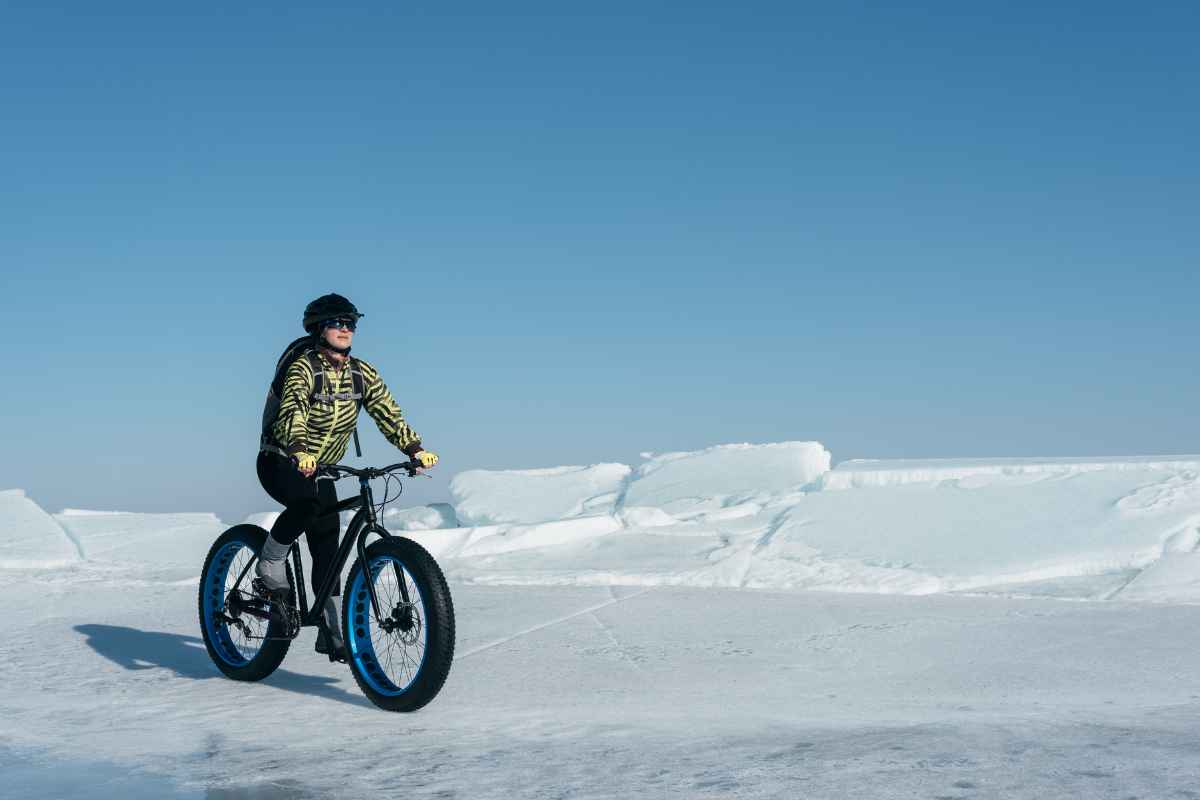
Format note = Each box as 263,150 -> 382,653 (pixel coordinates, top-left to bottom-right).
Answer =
342,536 -> 455,711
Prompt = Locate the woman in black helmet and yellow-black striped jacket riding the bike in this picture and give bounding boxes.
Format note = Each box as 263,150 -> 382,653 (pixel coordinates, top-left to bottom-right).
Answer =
256,294 -> 438,661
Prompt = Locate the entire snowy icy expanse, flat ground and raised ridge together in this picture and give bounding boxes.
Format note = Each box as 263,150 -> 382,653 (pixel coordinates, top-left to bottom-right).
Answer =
0,441 -> 1200,798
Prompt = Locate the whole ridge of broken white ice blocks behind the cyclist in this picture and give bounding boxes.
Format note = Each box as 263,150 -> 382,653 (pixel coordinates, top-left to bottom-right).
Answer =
4,443 -> 1200,602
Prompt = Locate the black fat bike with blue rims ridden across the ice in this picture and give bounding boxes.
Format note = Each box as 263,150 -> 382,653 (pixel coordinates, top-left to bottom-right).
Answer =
198,462 -> 455,711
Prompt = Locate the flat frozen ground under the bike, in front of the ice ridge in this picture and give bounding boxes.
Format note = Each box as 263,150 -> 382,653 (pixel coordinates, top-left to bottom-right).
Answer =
7,571 -> 1200,799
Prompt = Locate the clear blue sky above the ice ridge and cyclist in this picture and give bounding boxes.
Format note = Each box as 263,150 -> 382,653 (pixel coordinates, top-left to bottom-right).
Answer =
0,2 -> 1200,517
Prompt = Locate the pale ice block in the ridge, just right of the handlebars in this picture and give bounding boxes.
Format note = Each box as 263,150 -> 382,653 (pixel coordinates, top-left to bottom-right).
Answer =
450,464 -> 630,525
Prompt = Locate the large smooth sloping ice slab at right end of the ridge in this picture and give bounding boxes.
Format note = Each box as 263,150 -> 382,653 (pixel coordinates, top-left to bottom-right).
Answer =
758,468 -> 1200,589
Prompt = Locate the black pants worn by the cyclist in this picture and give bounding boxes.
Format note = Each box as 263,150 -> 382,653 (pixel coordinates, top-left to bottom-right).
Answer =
258,452 -> 342,595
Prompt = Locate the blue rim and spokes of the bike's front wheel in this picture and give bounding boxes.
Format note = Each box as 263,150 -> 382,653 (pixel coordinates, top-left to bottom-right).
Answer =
347,555 -> 428,697
